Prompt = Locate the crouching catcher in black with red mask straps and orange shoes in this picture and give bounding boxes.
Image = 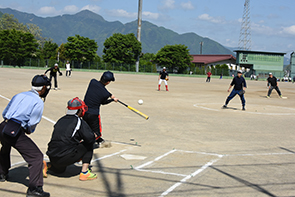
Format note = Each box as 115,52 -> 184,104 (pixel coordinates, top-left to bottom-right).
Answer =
43,97 -> 97,181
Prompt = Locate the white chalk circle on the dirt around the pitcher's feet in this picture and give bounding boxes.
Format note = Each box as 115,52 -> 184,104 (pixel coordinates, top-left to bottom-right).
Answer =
193,103 -> 295,116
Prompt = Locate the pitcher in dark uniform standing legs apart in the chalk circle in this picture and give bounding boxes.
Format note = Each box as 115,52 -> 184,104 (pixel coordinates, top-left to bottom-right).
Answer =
223,70 -> 247,110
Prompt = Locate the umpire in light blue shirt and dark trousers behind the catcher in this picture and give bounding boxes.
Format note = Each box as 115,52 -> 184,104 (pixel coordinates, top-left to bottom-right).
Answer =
0,75 -> 51,197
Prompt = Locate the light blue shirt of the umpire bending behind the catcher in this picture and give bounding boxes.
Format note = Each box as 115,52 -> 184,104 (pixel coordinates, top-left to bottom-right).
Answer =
2,89 -> 44,133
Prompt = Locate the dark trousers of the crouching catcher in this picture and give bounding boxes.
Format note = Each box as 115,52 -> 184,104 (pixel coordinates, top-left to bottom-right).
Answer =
49,143 -> 93,173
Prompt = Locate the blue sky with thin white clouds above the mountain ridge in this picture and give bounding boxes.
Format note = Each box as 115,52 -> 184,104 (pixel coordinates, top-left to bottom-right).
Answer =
0,0 -> 295,53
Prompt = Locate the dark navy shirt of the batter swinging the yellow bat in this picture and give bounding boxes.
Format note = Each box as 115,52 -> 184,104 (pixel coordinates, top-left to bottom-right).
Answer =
84,79 -> 113,115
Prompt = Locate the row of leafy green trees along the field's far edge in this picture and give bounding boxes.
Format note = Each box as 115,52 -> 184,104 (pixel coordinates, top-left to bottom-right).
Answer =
0,14 -> 208,73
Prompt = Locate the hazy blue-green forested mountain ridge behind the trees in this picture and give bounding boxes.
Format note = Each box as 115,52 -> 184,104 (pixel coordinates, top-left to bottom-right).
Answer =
0,8 -> 232,55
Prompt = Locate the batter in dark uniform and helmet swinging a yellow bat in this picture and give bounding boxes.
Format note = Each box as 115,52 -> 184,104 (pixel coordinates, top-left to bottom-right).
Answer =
83,71 -> 118,145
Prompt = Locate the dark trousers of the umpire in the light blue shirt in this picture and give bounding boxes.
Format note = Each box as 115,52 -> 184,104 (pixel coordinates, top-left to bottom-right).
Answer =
0,122 -> 43,188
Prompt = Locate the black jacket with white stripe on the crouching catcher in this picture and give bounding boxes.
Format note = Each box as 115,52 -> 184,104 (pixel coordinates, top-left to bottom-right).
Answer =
46,115 -> 95,157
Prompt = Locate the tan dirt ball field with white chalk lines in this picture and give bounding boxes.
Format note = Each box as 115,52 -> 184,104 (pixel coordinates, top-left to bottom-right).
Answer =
0,68 -> 295,197
